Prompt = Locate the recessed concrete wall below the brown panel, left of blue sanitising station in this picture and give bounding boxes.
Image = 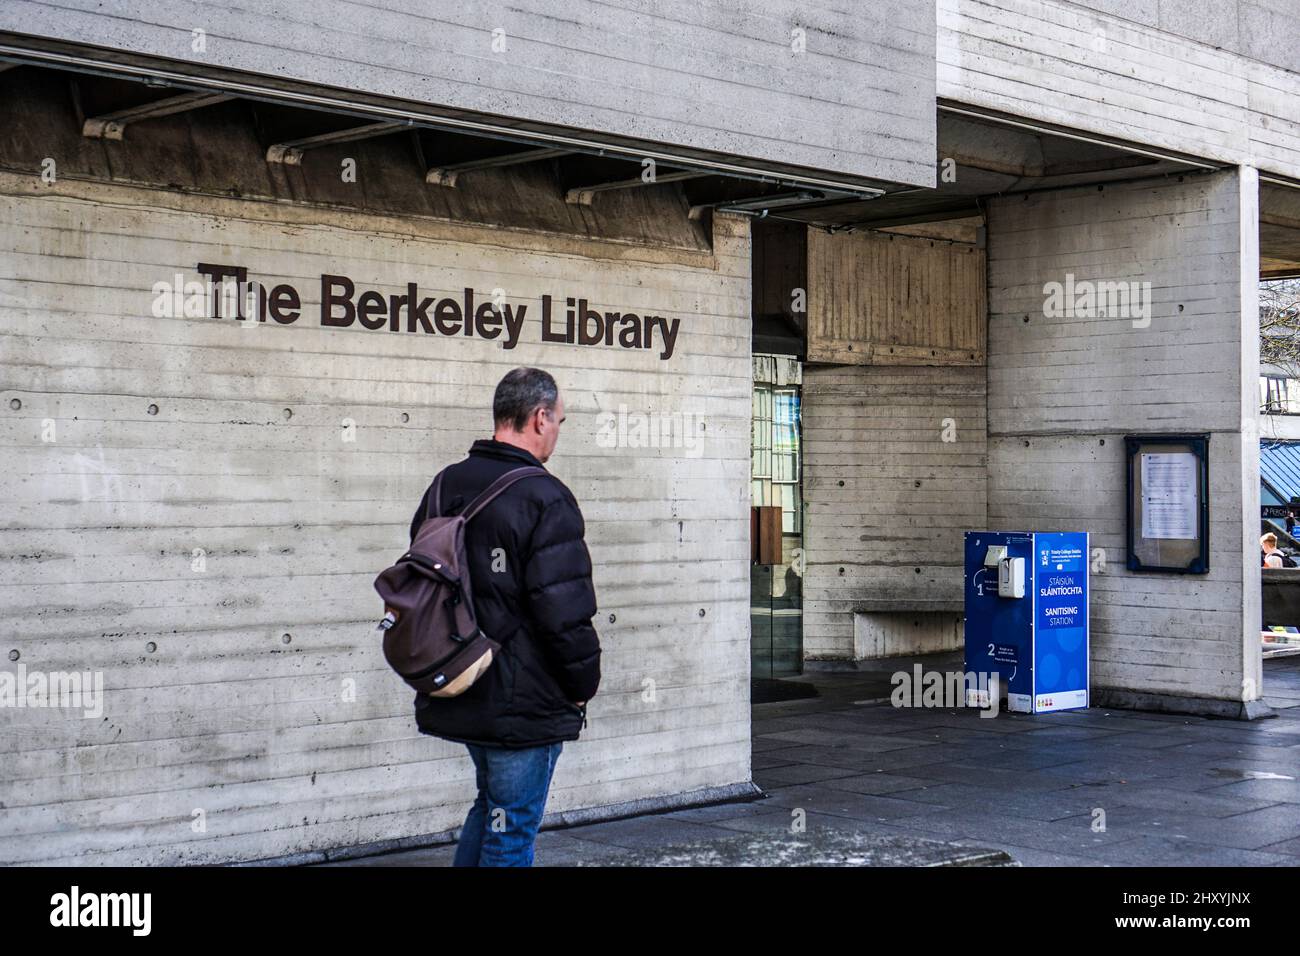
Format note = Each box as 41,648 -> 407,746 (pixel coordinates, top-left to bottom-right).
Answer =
803,365 -> 987,659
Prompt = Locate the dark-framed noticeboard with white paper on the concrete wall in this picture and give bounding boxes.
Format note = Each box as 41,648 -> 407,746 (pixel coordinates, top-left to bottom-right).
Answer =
1125,434 -> 1210,574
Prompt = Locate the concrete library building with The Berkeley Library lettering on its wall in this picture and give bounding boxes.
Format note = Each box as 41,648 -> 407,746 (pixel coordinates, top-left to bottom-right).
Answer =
0,0 -> 1300,864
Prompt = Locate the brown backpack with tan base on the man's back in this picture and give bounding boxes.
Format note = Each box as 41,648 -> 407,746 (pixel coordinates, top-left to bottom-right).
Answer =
374,466 -> 549,697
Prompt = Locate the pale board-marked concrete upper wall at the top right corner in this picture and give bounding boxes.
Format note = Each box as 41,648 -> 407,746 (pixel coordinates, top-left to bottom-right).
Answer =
937,0 -> 1300,177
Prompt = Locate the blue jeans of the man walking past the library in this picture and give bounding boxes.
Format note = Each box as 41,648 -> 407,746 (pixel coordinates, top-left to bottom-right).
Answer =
451,741 -> 564,866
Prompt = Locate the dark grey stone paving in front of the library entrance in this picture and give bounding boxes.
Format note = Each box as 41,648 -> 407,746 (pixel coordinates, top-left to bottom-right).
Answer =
322,654 -> 1300,866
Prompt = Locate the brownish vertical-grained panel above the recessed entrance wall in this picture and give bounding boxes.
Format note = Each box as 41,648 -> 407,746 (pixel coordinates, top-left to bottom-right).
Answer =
809,229 -> 987,365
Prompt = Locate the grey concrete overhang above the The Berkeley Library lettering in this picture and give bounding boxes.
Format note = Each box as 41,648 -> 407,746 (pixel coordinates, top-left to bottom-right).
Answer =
0,0 -> 935,186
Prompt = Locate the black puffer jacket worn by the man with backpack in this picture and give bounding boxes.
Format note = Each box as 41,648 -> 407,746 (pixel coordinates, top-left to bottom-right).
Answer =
411,438 -> 601,747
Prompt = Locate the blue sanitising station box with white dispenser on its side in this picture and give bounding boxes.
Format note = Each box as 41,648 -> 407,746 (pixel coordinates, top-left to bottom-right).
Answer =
966,531 -> 1089,713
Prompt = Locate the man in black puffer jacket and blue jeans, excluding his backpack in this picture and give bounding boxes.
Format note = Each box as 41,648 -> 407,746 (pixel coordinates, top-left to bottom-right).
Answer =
411,368 -> 601,866
